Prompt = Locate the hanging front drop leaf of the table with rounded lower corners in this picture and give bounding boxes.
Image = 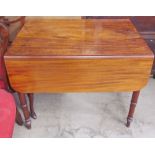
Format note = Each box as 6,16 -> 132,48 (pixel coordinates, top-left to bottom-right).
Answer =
6,57 -> 152,93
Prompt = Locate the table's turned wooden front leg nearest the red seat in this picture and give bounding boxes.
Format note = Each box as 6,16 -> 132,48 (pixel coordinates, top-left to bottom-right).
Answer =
18,93 -> 31,129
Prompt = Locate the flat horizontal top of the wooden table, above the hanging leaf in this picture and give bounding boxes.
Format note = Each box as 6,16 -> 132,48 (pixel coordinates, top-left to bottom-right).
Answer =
6,19 -> 152,57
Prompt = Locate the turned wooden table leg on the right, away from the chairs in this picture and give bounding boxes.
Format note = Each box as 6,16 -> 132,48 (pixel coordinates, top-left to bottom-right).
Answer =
126,91 -> 140,127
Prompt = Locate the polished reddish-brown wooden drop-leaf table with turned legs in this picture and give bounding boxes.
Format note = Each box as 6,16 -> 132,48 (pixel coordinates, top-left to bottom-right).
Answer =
5,19 -> 153,128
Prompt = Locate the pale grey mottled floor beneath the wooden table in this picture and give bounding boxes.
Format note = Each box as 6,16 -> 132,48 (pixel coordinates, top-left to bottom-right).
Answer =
13,78 -> 155,138
